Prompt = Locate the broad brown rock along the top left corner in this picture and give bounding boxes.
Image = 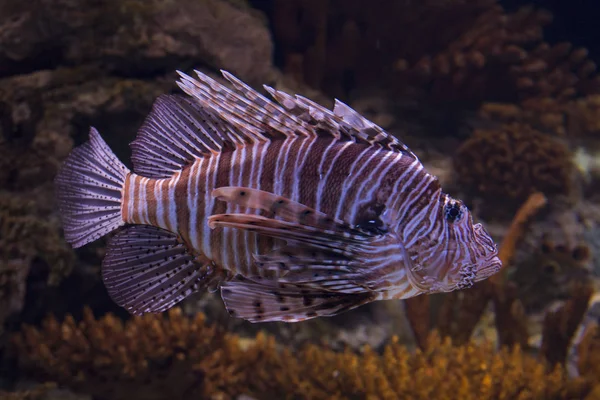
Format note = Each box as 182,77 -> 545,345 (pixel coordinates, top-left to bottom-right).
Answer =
0,0 -> 273,83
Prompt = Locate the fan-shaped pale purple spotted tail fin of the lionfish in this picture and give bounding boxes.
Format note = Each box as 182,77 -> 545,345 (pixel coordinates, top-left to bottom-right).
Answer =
54,128 -> 129,248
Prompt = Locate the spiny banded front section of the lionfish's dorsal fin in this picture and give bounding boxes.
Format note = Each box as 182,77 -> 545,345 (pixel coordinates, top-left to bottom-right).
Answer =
178,71 -> 417,159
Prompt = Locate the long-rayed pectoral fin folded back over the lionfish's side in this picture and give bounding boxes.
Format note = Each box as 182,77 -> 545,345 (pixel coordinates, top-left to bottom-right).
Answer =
209,196 -> 389,294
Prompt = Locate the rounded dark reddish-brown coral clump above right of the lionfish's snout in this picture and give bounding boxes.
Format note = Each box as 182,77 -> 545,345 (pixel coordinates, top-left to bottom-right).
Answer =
454,123 -> 574,204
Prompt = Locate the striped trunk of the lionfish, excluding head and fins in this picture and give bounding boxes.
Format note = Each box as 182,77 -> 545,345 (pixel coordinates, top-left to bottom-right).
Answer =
122,137 -> 432,295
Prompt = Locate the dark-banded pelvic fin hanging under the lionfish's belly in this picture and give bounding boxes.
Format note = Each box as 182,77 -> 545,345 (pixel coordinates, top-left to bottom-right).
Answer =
221,277 -> 373,322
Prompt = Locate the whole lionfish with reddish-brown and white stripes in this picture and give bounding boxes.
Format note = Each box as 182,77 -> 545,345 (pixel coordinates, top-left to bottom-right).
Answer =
55,71 -> 502,322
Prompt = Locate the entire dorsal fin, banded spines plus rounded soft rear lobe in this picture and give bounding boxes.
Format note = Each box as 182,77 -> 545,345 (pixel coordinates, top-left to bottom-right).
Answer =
131,71 -> 416,178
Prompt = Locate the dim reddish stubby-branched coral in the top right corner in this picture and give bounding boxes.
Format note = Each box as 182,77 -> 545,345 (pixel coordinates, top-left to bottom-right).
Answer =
397,7 -> 599,101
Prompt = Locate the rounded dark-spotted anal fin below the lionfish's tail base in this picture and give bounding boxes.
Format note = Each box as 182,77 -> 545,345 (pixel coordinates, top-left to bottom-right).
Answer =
102,225 -> 219,315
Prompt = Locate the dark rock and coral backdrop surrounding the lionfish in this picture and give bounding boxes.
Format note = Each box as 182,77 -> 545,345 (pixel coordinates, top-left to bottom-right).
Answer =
0,0 -> 600,399
